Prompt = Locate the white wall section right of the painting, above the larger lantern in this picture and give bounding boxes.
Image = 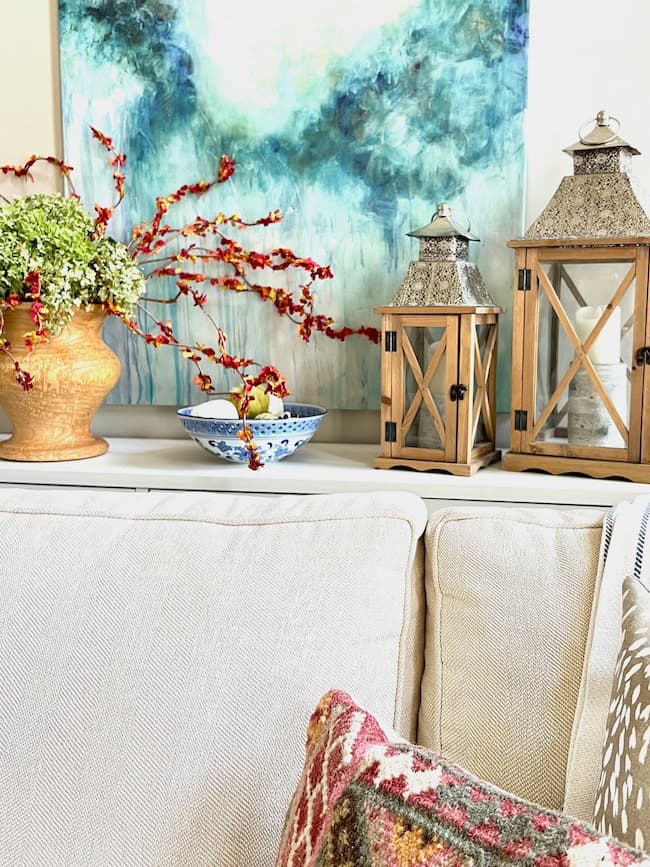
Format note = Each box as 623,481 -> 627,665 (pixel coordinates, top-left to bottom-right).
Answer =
526,0 -> 650,225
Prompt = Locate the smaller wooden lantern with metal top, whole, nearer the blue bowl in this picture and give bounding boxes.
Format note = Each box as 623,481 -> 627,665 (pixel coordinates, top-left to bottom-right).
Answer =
375,204 -> 501,476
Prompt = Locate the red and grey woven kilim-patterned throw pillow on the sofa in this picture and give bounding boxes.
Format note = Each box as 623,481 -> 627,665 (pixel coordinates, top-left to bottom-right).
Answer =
276,692 -> 650,867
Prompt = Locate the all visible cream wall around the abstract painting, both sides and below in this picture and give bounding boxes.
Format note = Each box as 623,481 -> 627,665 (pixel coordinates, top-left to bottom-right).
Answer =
0,0 -> 650,444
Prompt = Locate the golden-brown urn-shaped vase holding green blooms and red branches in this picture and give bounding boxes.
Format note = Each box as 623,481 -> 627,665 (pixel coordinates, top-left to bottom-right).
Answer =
0,304 -> 120,461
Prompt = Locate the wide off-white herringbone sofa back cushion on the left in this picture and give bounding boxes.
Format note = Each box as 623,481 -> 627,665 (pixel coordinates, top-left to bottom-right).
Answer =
0,491 -> 426,867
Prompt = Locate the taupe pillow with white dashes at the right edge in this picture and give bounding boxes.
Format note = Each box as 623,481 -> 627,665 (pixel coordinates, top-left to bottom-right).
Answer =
594,578 -> 650,849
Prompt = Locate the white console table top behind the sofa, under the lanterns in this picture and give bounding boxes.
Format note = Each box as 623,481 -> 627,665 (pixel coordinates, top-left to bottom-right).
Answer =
0,438 -> 650,509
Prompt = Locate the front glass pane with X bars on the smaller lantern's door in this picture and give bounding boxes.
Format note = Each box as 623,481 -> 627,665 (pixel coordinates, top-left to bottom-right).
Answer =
402,326 -> 447,451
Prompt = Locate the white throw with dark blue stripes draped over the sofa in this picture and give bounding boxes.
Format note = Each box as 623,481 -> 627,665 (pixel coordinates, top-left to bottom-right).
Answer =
564,497 -> 650,821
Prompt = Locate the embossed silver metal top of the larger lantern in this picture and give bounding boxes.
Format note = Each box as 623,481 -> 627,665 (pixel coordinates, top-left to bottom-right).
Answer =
524,111 -> 650,241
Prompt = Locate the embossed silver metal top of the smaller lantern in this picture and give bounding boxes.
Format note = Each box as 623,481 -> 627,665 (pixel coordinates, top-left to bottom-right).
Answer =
391,202 -> 494,307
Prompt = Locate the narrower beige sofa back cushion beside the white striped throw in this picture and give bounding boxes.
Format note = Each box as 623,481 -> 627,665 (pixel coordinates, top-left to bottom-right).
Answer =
418,507 -> 602,809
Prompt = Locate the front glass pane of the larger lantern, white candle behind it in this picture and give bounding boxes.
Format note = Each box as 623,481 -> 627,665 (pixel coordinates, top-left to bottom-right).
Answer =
533,257 -> 635,449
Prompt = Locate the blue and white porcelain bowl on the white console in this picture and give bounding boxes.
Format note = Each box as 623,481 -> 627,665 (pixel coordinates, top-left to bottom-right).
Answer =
177,403 -> 327,464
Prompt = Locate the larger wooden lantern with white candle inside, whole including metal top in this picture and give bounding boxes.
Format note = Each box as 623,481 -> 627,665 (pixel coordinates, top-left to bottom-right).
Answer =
504,112 -> 650,482
